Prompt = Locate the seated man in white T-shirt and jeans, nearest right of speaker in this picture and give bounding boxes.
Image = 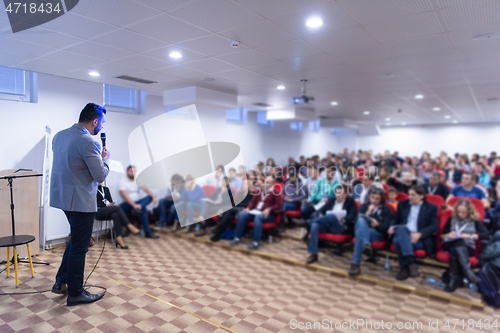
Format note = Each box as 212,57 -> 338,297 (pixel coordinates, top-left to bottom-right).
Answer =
120,165 -> 159,238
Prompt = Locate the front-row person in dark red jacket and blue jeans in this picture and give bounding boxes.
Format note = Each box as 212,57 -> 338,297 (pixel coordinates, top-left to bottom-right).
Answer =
230,176 -> 283,250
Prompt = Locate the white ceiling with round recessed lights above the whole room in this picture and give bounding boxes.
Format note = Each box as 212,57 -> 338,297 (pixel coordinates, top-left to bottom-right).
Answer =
0,0 -> 500,125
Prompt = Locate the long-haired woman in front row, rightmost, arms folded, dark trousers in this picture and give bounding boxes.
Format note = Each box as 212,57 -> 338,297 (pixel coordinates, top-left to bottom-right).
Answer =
441,199 -> 489,292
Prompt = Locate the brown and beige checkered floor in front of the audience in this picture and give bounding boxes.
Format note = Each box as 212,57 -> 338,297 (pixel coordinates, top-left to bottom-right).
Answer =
0,228 -> 498,333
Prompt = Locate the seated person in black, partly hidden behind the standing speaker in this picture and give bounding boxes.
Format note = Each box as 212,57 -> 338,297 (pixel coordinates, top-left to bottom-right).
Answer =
95,184 -> 139,250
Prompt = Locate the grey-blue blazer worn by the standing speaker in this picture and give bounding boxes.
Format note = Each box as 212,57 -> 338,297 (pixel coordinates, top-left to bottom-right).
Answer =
50,124 -> 109,213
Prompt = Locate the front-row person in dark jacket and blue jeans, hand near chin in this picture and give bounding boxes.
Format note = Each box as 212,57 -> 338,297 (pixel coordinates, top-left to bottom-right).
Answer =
349,188 -> 392,276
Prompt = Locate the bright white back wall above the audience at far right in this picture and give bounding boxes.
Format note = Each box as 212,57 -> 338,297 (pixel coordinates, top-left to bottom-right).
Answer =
358,124 -> 500,157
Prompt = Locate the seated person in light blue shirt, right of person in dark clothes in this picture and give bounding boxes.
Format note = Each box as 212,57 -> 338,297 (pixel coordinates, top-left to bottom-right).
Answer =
176,175 -> 205,233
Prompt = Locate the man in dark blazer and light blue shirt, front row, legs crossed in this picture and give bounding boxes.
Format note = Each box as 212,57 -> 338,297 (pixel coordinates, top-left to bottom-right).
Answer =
388,185 -> 438,280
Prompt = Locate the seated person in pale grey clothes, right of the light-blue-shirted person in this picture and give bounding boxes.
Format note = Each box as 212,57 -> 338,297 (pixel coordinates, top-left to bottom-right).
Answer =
194,178 -> 235,237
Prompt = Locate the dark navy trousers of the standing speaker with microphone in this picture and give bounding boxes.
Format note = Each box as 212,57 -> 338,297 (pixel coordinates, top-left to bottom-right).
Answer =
56,211 -> 95,297
